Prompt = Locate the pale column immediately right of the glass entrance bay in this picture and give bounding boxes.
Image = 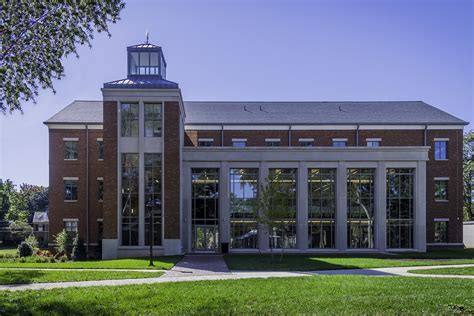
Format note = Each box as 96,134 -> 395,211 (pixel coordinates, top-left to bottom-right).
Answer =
219,161 -> 230,243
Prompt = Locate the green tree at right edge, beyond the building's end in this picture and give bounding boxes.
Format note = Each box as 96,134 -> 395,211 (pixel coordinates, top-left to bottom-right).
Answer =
463,130 -> 474,221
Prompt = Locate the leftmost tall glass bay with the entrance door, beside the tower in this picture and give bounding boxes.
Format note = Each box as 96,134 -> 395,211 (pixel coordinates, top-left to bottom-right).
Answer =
191,168 -> 219,251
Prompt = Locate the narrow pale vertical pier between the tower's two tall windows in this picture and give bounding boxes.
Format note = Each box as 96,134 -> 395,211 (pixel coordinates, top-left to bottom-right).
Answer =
138,101 -> 145,246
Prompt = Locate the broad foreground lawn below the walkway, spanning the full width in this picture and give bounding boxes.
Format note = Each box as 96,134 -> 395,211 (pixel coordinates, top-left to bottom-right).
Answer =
0,276 -> 474,315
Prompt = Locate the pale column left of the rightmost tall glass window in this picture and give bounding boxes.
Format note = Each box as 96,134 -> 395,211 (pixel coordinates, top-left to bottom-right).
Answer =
375,161 -> 387,251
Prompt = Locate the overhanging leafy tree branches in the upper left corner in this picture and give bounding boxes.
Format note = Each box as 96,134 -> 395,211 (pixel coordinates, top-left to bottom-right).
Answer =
0,0 -> 125,114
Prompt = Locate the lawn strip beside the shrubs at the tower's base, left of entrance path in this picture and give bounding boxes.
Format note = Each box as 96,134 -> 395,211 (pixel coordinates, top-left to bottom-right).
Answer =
0,256 -> 181,270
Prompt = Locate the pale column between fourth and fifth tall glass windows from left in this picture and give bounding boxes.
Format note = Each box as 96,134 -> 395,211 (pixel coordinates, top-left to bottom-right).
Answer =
336,161 -> 347,251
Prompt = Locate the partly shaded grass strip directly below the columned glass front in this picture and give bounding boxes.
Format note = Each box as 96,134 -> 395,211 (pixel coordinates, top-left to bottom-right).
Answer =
224,249 -> 474,271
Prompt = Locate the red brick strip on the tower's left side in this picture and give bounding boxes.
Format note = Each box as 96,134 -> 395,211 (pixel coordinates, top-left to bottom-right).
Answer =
103,101 -> 118,239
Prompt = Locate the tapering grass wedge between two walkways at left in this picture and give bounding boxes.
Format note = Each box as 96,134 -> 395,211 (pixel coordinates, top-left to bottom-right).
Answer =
0,270 -> 163,284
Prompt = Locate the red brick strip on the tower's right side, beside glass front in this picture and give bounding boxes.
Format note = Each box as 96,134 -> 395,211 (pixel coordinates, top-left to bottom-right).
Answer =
163,102 -> 181,239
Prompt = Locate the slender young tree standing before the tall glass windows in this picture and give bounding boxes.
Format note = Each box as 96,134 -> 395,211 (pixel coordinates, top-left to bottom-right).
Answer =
257,173 -> 296,261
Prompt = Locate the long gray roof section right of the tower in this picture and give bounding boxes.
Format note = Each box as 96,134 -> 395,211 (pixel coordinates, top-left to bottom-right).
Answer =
184,101 -> 468,125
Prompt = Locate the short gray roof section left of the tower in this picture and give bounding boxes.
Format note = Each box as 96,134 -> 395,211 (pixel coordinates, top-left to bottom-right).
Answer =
44,101 -> 103,124
